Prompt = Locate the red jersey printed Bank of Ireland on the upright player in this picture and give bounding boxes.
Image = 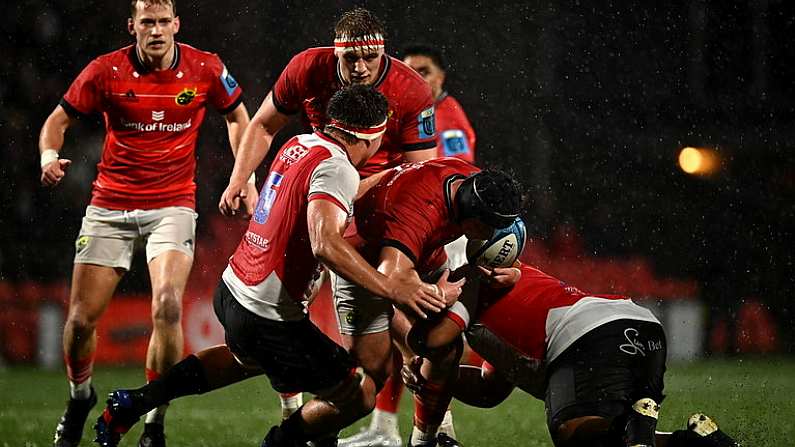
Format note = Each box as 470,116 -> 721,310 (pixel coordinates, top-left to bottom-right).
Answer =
61,43 -> 242,210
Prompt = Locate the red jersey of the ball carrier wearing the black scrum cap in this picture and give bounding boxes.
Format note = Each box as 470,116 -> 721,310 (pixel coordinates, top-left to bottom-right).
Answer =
355,158 -> 480,274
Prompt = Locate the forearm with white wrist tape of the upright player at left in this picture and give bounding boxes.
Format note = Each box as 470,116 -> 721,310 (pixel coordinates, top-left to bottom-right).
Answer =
39,104 -> 74,186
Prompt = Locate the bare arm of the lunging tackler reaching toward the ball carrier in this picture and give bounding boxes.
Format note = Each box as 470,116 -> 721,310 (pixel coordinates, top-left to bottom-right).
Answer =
307,199 -> 458,316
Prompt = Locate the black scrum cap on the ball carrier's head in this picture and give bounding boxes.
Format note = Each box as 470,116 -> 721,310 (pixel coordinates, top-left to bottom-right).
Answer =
456,170 -> 522,228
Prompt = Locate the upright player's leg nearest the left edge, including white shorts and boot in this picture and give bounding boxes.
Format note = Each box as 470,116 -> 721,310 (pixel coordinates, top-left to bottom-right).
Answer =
54,206 -> 137,446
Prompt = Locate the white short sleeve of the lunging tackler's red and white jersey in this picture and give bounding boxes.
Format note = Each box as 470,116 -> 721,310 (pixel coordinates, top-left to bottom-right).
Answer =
308,157 -> 359,216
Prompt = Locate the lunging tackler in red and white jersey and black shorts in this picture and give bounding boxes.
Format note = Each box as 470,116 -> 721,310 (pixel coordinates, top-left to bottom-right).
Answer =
95,86 -> 461,446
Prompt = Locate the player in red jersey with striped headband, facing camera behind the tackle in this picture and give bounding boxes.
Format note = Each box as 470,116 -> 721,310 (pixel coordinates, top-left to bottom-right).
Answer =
218,8 -> 436,426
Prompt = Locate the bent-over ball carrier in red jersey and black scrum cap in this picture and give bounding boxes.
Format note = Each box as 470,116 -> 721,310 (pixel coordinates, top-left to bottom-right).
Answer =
332,158 -> 521,445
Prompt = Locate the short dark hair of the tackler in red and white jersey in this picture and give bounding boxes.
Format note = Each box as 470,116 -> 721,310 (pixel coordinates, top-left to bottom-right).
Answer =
326,84 -> 389,143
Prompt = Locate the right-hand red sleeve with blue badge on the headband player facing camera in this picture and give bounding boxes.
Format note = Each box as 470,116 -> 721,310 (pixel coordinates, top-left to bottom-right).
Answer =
400,81 -> 436,152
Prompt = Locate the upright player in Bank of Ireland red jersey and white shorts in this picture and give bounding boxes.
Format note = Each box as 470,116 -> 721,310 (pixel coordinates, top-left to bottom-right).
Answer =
39,0 -> 250,446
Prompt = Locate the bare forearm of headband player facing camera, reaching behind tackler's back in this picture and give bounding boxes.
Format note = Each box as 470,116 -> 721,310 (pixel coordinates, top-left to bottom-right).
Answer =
218,92 -> 289,216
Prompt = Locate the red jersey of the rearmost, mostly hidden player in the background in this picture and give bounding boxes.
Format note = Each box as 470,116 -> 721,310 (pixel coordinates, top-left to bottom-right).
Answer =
436,92 -> 475,163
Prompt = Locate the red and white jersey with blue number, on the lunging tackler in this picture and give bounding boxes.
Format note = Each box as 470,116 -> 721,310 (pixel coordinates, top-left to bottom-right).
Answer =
224,133 -> 359,320
